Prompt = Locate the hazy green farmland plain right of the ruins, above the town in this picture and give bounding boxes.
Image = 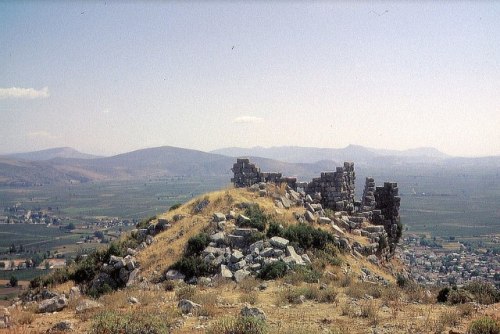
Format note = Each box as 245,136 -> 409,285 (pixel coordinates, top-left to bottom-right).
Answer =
357,166 -> 500,238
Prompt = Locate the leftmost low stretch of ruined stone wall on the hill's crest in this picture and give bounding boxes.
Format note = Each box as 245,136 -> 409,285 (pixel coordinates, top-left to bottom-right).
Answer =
231,159 -> 297,190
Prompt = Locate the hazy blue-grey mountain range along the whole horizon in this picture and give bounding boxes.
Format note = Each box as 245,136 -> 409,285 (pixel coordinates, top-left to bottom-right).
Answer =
0,145 -> 500,186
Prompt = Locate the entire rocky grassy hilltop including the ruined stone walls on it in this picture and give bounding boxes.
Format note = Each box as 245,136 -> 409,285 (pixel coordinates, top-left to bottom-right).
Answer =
0,159 -> 500,333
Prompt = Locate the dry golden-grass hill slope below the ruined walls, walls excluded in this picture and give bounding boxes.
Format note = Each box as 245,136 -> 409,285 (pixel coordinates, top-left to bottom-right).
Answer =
10,185 -> 500,334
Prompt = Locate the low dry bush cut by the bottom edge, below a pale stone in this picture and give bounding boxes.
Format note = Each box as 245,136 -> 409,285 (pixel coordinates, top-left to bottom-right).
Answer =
207,316 -> 268,334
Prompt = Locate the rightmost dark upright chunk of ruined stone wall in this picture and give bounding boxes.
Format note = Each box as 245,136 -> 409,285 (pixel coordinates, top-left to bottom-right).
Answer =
372,182 -> 402,252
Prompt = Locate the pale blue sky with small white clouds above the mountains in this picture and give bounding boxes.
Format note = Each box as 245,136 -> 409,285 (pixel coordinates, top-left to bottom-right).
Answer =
0,0 -> 500,156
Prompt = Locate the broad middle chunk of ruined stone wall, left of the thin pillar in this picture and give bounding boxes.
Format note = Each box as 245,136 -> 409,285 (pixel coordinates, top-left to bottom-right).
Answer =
305,162 -> 356,211
